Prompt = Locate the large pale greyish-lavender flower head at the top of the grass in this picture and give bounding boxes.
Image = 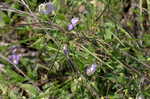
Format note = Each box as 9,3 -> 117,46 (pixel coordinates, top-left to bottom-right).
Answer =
39,2 -> 55,14
